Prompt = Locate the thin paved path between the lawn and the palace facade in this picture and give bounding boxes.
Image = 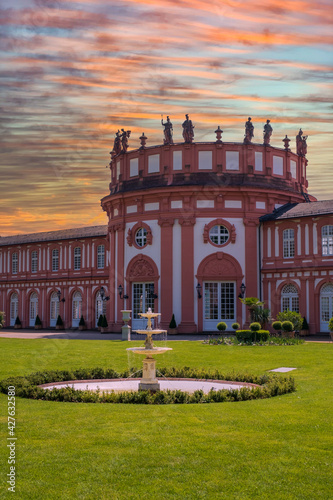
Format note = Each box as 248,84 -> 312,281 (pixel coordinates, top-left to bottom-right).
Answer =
0,328 -> 331,342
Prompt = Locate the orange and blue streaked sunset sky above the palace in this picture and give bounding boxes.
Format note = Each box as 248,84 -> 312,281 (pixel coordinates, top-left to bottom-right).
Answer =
0,0 -> 333,236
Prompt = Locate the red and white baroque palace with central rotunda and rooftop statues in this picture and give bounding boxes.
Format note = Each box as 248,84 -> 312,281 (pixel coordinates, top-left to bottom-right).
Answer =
0,119 -> 333,334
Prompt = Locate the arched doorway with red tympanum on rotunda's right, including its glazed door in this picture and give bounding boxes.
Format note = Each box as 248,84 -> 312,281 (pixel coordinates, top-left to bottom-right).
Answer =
197,252 -> 243,331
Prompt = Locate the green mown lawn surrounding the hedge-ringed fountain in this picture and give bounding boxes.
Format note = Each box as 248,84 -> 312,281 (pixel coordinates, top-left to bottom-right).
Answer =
0,339 -> 333,500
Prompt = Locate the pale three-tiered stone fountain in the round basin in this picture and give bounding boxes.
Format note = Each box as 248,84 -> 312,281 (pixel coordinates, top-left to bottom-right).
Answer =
127,308 -> 172,392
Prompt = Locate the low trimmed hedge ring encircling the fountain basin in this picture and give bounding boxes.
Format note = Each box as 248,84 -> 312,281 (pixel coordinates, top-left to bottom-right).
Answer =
0,367 -> 296,404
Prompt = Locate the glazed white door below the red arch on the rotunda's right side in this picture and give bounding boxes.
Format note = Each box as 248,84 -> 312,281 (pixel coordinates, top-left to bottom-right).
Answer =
203,281 -> 236,331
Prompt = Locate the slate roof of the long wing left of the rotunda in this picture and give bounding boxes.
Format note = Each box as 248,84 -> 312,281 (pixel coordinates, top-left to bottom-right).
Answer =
0,226 -> 108,246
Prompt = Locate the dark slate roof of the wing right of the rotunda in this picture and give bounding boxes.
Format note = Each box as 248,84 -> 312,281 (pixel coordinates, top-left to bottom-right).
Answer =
260,200 -> 333,222
